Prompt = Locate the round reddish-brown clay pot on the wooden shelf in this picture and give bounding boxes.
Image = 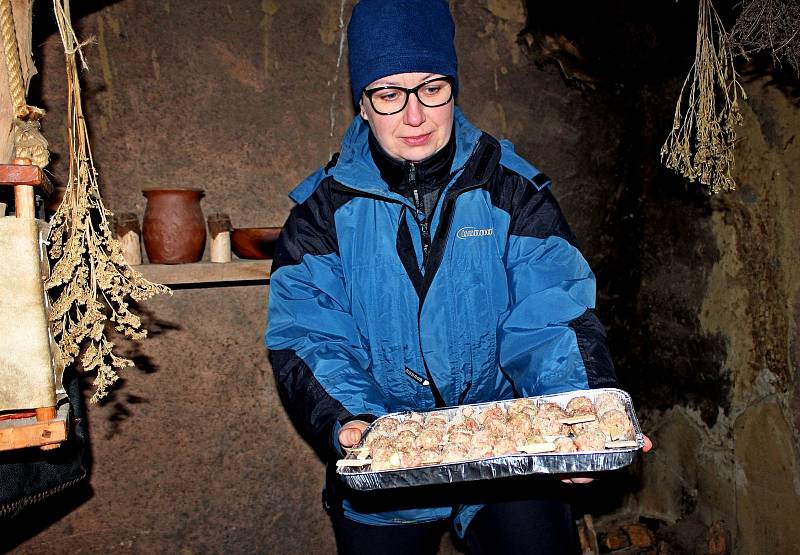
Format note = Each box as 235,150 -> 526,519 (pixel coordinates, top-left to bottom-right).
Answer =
142,187 -> 206,264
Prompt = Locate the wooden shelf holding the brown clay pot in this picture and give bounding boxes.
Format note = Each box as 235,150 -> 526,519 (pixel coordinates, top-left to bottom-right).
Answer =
133,260 -> 272,285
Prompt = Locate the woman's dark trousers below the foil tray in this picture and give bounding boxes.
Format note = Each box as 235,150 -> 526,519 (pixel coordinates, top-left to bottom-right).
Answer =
331,500 -> 580,555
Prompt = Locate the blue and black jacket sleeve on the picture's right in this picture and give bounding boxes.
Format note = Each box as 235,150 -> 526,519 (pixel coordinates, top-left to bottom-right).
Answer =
498,176 -> 618,396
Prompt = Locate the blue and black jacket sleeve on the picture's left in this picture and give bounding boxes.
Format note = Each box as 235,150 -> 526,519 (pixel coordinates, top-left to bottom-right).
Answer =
265,188 -> 386,456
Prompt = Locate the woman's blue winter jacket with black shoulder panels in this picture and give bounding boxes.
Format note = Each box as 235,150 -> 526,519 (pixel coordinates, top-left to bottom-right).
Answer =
266,108 -> 617,532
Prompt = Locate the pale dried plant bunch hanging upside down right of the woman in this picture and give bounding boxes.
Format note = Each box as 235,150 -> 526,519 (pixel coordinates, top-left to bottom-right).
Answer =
661,0 -> 747,194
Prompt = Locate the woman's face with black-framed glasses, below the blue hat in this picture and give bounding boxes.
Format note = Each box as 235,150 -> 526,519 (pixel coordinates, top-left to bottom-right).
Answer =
361,73 -> 454,162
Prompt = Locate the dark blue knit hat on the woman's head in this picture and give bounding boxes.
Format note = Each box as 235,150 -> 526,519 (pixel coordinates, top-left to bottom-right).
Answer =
347,0 -> 458,106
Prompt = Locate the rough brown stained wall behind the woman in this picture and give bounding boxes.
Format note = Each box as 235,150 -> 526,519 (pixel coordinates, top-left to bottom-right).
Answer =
0,0 -> 800,553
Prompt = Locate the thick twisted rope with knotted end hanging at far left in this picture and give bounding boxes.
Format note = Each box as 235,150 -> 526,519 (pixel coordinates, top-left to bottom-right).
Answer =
0,0 -> 50,168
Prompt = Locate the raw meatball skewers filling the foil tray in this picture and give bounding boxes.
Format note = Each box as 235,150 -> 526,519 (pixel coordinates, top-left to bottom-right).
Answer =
344,391 -> 636,471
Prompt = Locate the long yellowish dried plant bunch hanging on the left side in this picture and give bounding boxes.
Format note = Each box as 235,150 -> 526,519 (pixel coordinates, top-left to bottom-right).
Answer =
46,0 -> 169,402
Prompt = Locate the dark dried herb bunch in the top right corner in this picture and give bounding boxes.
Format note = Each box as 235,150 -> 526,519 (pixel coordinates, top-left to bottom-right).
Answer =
731,0 -> 800,76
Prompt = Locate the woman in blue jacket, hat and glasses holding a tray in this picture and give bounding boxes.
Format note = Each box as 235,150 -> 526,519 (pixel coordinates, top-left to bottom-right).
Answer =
266,0 -> 648,553
